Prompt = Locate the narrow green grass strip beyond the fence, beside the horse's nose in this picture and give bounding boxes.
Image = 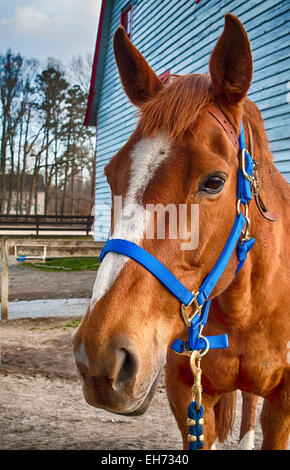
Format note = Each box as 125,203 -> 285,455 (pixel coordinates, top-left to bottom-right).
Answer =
23,257 -> 100,272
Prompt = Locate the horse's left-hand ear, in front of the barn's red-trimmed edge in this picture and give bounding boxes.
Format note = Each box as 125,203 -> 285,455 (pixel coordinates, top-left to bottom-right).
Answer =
113,26 -> 163,107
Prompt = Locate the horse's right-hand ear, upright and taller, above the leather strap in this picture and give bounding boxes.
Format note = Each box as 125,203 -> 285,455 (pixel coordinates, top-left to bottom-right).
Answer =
209,13 -> 253,104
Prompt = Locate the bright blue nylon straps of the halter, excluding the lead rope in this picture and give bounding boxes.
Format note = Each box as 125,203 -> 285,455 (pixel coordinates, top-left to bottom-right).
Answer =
100,119 -> 255,353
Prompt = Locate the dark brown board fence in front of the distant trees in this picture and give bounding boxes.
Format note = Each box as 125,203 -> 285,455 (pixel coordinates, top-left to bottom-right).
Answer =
0,214 -> 94,235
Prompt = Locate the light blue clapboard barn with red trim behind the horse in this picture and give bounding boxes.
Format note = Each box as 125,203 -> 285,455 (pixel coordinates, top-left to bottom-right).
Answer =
85,0 -> 290,241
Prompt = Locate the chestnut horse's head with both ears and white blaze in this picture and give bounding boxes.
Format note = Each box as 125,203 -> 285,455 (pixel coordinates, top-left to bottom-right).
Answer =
73,14 -> 252,414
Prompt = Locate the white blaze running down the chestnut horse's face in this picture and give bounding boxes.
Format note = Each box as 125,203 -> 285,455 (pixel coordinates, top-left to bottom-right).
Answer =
90,134 -> 170,309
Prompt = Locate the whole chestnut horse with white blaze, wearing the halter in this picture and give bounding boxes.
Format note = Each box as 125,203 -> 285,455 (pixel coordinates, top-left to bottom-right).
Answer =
73,14 -> 290,449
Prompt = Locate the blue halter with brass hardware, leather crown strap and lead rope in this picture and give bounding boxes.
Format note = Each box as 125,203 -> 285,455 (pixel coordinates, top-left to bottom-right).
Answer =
100,105 -> 274,450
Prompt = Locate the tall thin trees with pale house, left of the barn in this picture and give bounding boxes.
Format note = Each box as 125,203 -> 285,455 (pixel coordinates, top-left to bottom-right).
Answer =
0,50 -> 95,215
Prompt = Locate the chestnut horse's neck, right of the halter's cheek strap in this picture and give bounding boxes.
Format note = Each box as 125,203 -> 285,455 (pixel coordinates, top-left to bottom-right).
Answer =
216,133 -> 290,328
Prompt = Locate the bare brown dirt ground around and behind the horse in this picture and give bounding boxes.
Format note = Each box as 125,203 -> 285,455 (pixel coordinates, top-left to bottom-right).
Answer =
0,263 -> 268,450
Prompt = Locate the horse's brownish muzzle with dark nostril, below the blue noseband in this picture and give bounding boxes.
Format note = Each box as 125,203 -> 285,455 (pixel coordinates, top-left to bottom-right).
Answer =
75,335 -> 160,415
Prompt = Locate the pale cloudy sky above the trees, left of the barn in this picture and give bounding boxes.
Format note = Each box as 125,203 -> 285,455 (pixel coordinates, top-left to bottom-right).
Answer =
0,0 -> 101,64
